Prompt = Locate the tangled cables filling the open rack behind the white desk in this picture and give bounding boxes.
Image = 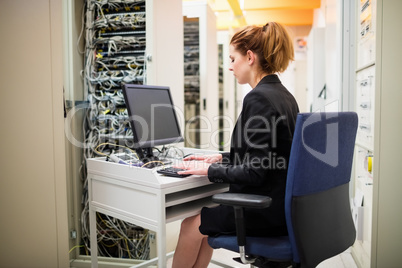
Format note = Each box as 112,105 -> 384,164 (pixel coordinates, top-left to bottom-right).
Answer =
80,0 -> 149,260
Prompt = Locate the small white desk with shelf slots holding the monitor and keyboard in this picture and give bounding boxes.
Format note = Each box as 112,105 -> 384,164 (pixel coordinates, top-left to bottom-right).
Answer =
87,150 -> 228,268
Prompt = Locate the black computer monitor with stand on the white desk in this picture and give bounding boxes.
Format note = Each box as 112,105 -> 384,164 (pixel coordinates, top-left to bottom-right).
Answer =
123,84 -> 184,163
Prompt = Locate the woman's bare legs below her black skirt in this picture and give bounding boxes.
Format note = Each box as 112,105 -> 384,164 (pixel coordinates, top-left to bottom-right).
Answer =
172,215 -> 212,268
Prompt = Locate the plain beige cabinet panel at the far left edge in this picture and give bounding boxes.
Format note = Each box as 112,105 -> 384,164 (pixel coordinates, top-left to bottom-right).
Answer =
0,0 -> 69,268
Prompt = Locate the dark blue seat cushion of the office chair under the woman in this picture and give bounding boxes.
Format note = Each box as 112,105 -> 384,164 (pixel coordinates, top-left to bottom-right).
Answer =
208,235 -> 293,261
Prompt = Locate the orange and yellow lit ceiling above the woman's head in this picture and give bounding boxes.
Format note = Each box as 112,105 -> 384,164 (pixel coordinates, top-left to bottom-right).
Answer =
184,0 -> 321,30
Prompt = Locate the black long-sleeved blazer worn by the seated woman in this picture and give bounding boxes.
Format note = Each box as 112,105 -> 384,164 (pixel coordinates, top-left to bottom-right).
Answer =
208,75 -> 299,235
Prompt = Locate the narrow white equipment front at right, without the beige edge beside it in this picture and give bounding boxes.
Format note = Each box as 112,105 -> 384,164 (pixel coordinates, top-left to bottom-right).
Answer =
353,1 -> 376,267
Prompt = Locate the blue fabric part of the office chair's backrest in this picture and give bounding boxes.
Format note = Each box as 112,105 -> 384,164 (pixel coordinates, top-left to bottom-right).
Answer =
285,112 -> 358,262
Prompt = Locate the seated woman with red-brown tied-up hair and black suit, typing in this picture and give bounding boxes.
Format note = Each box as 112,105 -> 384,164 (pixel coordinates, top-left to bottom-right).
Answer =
173,22 -> 299,268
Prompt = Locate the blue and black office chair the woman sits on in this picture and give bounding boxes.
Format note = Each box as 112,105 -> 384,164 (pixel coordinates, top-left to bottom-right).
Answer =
208,112 -> 357,267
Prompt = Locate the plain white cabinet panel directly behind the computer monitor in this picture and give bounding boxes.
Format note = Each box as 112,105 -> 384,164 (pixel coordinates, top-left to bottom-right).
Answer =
146,0 -> 184,111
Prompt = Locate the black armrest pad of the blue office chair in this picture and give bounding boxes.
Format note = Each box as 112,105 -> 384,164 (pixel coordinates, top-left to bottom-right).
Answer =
212,193 -> 272,208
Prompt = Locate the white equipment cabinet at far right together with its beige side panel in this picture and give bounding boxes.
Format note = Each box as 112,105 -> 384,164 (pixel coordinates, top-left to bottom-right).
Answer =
352,0 -> 402,267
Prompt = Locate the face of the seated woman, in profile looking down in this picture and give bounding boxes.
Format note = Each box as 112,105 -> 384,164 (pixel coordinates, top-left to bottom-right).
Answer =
229,45 -> 250,84
